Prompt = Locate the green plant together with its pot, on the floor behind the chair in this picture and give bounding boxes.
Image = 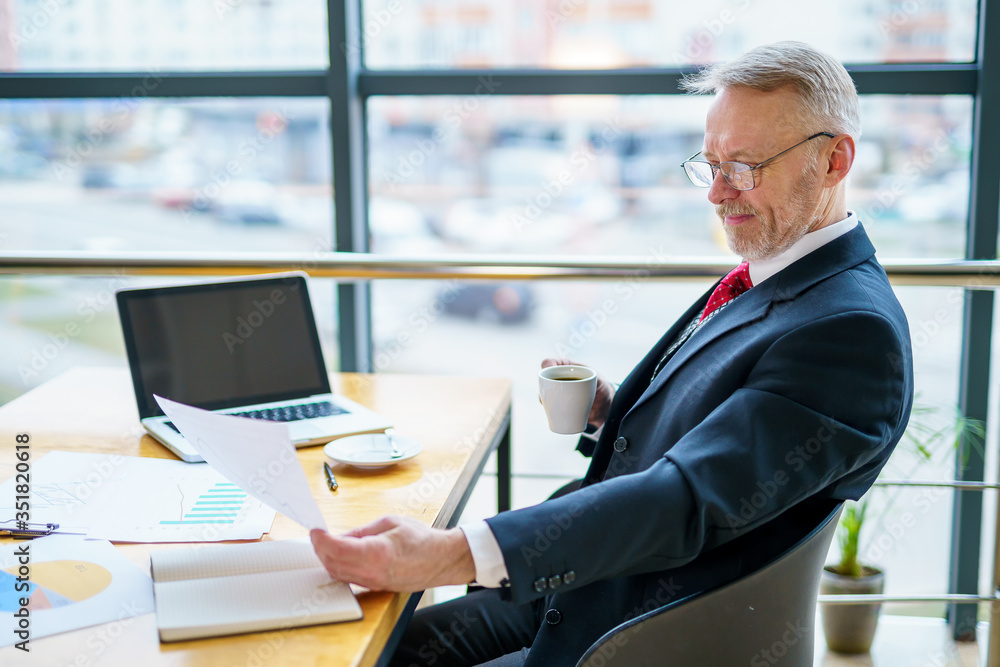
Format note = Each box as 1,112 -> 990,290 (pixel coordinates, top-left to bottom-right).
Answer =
820,404 -> 986,653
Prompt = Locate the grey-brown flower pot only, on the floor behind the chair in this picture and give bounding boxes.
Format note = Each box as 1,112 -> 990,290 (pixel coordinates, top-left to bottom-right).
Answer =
819,565 -> 885,653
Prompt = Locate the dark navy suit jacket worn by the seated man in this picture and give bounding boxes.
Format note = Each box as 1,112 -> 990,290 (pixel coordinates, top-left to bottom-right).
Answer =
488,224 -> 913,667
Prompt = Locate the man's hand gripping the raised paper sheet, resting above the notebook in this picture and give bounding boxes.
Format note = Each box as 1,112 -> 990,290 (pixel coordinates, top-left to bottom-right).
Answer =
309,516 -> 476,592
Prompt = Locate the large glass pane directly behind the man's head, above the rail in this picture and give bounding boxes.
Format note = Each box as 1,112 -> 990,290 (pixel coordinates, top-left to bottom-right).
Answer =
369,96 -> 972,261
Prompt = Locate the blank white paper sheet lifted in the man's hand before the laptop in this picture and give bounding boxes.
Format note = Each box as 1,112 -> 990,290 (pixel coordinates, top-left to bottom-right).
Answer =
155,396 -> 326,530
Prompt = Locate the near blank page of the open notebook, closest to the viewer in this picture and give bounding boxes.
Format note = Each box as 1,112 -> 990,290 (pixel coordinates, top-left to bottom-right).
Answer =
154,568 -> 362,641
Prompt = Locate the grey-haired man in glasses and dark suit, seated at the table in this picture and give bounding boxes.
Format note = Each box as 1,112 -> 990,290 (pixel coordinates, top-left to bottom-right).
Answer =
312,42 -> 913,666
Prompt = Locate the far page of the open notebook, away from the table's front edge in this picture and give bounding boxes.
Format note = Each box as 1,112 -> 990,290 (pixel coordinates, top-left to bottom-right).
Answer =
149,540 -> 322,582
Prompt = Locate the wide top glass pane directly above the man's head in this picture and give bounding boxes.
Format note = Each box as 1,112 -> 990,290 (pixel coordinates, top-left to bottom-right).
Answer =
363,0 -> 977,69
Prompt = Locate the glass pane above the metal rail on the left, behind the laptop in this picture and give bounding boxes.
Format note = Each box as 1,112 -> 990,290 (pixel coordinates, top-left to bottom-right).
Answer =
0,98 -> 333,251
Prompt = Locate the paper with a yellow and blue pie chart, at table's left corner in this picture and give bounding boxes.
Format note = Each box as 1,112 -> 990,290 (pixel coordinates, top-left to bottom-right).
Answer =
0,535 -> 154,648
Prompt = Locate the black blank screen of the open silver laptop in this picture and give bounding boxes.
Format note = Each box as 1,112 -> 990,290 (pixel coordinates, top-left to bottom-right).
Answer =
117,275 -> 330,418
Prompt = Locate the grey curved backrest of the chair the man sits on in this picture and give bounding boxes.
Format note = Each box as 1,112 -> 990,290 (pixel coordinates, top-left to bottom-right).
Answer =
577,504 -> 843,667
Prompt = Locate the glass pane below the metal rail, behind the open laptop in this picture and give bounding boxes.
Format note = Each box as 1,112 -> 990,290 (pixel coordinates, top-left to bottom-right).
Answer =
0,275 -> 340,404
